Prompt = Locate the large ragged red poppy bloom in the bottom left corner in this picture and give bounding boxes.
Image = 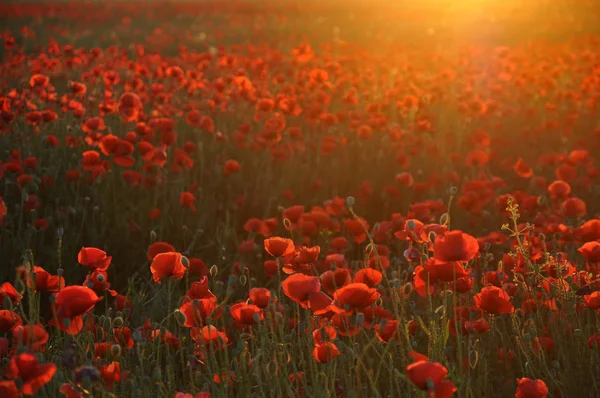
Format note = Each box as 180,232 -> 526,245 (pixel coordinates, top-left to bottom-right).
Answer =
9,353 -> 56,395
